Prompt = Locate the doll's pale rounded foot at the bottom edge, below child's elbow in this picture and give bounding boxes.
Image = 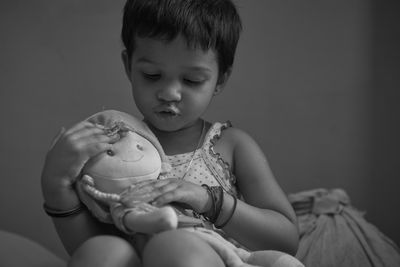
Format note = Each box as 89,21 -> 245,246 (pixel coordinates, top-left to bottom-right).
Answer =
247,250 -> 304,267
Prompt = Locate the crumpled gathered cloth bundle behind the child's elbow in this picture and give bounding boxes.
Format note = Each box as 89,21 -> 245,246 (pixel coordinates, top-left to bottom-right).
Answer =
289,189 -> 400,267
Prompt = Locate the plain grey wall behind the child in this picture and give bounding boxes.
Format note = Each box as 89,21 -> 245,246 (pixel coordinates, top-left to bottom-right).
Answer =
0,0 -> 400,257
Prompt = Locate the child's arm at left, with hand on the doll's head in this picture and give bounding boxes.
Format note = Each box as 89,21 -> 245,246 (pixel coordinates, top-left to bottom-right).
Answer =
41,121 -> 119,254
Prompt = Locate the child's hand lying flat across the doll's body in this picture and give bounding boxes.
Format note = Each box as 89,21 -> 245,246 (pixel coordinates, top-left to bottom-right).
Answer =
126,178 -> 211,213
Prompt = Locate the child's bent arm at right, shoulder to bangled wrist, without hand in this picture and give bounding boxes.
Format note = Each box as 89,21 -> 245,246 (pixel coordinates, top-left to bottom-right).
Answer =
215,128 -> 298,254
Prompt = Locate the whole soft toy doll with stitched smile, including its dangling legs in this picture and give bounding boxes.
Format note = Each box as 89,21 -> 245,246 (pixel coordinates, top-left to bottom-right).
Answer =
77,110 -> 304,267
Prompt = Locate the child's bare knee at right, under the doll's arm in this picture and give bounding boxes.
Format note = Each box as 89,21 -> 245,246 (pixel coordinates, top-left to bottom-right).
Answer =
143,229 -> 225,267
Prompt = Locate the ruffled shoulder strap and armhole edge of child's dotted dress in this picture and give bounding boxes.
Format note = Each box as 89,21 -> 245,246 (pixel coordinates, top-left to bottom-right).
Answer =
201,121 -> 239,196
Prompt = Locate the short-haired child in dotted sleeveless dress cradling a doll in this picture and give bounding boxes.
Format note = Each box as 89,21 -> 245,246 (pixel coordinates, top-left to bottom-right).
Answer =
42,0 -> 298,267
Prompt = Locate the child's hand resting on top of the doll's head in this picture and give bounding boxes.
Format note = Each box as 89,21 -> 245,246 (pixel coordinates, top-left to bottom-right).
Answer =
42,121 -> 120,186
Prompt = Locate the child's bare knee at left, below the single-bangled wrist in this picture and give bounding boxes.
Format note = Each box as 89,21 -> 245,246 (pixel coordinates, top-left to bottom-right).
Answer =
68,235 -> 142,267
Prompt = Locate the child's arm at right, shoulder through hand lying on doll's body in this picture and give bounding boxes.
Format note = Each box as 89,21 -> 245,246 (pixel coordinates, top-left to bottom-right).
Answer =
133,128 -> 298,254
